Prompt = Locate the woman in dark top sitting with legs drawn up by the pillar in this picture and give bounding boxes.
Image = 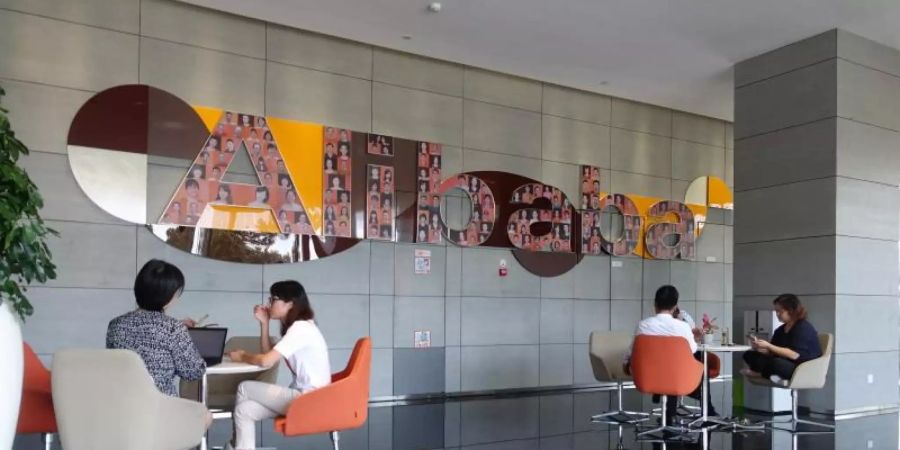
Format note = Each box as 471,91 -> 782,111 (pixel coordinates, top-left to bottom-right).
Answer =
741,294 -> 822,383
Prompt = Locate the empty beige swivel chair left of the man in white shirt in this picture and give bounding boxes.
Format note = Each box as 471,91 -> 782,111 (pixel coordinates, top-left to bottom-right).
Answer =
590,331 -> 648,424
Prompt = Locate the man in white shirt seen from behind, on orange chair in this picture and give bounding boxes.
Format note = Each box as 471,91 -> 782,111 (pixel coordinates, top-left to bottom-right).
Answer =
625,285 -> 718,423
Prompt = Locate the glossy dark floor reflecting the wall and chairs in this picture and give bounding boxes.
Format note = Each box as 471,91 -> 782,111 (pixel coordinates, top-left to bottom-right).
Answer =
8,383 -> 900,450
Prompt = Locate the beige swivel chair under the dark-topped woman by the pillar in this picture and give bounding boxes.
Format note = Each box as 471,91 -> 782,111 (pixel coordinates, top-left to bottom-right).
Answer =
746,333 -> 834,433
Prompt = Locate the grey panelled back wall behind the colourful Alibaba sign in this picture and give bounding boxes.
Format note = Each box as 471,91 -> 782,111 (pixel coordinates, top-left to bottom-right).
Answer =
0,0 -> 733,422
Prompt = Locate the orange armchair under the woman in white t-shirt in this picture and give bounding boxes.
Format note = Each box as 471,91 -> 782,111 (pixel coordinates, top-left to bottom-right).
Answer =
275,337 -> 372,450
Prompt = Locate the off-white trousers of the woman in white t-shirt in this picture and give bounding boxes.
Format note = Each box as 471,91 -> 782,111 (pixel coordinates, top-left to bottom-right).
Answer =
233,381 -> 300,450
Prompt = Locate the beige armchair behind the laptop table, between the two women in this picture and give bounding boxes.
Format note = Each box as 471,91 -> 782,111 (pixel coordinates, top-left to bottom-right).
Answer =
178,336 -> 280,412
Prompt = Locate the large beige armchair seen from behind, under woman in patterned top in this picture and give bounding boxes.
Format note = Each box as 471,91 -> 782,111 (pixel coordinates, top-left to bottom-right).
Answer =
51,349 -> 207,450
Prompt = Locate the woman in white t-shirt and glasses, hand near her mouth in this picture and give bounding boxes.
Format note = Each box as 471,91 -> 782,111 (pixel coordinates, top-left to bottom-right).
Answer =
228,281 -> 331,450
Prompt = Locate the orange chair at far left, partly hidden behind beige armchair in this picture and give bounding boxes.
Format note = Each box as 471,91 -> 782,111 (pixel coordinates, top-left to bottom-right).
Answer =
16,344 -> 57,450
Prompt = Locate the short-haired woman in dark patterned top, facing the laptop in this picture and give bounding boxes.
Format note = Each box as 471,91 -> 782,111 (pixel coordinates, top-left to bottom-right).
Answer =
106,259 -> 206,396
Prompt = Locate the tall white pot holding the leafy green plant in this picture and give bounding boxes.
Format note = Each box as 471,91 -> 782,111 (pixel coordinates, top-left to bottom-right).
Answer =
0,301 -> 24,448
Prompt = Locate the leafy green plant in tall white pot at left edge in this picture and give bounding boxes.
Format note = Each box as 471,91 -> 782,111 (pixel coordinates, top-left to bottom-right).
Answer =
0,87 -> 56,448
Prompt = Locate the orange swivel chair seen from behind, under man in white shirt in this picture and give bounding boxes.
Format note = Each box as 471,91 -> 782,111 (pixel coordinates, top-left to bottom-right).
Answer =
631,335 -> 703,436
